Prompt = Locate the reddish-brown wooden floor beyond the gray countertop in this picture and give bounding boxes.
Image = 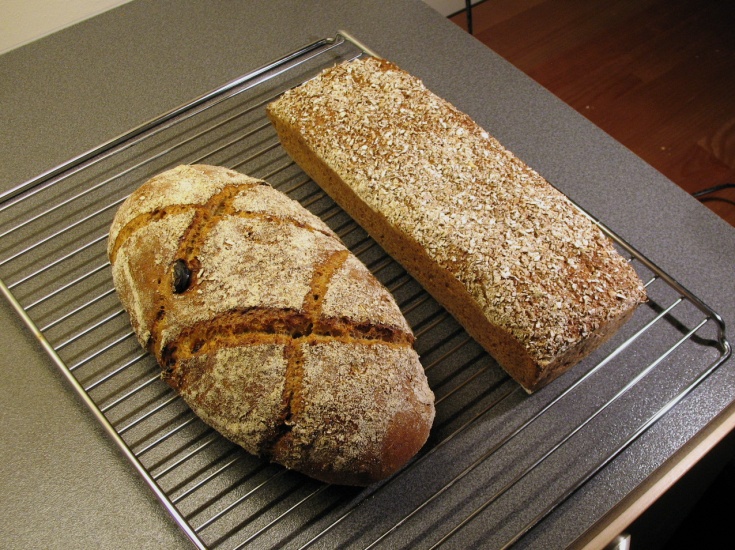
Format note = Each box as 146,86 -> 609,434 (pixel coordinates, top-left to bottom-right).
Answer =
451,0 -> 735,226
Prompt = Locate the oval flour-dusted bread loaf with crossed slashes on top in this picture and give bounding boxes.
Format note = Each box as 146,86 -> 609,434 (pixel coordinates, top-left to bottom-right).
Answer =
108,165 -> 434,485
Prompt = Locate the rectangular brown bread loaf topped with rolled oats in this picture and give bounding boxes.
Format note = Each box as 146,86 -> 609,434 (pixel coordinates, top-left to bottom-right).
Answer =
267,57 -> 645,392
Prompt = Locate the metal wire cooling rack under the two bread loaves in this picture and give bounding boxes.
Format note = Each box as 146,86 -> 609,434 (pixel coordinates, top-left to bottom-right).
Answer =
0,33 -> 730,549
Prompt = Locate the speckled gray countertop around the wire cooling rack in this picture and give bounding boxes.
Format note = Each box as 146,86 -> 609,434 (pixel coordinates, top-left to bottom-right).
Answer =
0,0 -> 735,548
